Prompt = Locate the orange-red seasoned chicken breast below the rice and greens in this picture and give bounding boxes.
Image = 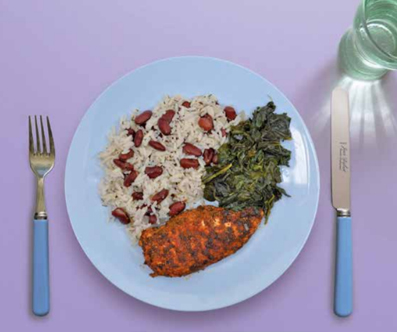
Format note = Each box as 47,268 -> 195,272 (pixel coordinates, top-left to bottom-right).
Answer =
139,205 -> 263,277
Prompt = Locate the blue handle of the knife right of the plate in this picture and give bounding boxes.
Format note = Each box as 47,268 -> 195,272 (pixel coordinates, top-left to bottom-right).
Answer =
334,217 -> 353,317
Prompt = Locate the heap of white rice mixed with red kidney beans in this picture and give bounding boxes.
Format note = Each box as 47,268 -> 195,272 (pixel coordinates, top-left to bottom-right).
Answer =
99,95 -> 244,242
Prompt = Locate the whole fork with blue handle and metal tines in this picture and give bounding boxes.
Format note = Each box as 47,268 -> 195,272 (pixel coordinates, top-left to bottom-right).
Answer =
29,115 -> 55,316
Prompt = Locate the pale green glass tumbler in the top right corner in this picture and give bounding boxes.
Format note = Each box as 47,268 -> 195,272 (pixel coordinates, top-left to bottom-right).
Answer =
339,0 -> 397,80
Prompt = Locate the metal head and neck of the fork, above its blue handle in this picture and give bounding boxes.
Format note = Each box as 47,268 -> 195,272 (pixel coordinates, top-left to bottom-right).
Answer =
29,115 -> 55,219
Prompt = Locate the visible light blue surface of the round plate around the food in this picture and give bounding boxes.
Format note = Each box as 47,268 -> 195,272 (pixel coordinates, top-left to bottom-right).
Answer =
65,57 -> 320,311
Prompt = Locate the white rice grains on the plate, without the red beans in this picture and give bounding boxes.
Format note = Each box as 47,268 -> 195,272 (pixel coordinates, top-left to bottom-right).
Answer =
99,95 -> 244,241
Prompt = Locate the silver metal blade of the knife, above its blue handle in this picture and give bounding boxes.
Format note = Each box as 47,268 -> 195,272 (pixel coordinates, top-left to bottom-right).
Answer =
331,87 -> 350,216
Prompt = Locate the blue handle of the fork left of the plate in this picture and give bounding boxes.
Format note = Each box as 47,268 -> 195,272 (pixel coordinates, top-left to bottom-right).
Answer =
32,219 -> 50,316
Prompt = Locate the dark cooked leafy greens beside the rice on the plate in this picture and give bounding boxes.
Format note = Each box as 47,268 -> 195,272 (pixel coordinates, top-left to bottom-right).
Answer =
203,102 -> 291,221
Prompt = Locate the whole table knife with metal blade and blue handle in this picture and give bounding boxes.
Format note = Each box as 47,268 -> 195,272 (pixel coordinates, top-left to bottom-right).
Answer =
331,87 -> 353,317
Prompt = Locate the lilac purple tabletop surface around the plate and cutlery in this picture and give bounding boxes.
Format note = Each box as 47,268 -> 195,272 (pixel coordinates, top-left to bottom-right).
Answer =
0,0 -> 397,332
